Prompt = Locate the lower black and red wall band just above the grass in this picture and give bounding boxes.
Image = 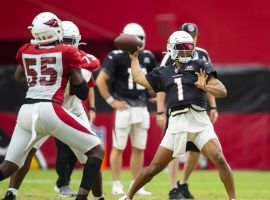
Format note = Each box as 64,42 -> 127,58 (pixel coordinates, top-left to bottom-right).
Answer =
0,65 -> 270,170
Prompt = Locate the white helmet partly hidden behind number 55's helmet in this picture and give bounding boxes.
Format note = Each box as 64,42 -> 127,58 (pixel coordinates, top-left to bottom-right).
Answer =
62,21 -> 81,46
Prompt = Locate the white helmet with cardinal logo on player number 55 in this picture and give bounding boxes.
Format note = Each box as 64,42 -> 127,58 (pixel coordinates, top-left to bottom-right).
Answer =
28,12 -> 63,45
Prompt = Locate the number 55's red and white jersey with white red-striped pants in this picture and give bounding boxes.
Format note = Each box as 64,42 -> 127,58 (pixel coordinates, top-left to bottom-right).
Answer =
5,44 -> 101,167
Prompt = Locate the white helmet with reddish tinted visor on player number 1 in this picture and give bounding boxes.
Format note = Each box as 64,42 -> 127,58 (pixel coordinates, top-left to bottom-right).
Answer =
167,31 -> 195,63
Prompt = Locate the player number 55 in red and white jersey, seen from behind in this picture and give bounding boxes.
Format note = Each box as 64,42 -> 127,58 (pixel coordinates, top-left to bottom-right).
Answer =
0,12 -> 104,200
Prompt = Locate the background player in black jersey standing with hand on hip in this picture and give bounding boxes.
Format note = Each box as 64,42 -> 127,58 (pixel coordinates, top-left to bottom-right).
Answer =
96,23 -> 156,195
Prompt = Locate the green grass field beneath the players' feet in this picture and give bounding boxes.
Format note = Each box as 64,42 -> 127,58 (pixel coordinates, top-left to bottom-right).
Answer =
0,170 -> 270,200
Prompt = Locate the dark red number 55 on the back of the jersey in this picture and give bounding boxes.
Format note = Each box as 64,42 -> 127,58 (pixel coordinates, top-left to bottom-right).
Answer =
25,57 -> 57,87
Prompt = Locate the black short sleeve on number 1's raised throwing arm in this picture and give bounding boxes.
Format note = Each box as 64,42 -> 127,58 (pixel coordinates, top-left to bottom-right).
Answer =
145,67 -> 164,93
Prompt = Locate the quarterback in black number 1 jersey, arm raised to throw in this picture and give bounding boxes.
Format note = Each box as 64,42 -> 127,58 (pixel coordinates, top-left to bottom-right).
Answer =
120,31 -> 235,200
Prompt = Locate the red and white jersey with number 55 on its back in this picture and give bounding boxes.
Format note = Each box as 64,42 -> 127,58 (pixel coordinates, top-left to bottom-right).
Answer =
16,44 -> 81,104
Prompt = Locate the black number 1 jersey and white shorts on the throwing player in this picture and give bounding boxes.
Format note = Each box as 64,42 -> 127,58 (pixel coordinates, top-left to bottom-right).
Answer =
146,60 -> 217,157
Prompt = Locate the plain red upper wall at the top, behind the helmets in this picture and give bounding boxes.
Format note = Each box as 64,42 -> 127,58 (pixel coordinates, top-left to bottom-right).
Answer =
0,0 -> 270,63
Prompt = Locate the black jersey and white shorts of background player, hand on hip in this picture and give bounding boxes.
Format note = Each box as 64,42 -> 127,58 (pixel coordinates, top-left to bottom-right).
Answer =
103,50 -> 156,150
